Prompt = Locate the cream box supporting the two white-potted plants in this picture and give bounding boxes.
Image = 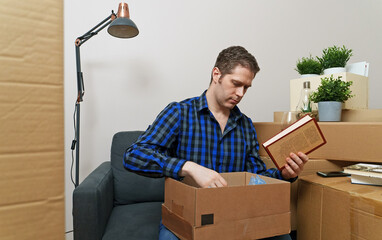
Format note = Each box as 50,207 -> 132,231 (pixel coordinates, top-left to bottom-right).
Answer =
289,72 -> 369,111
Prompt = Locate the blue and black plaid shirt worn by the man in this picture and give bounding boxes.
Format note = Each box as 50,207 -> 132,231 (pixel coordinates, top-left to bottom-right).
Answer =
124,92 -> 282,179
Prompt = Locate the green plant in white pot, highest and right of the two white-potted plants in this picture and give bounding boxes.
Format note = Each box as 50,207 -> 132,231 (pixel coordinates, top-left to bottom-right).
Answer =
317,45 -> 353,75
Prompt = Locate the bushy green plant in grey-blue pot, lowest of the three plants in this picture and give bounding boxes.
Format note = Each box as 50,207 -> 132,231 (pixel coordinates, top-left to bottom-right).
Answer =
309,75 -> 353,121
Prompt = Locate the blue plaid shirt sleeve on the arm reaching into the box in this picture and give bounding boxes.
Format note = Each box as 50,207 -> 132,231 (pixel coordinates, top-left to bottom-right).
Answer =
123,103 -> 186,179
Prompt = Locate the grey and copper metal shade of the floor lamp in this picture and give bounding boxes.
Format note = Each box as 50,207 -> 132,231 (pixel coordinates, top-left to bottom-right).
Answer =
107,3 -> 139,38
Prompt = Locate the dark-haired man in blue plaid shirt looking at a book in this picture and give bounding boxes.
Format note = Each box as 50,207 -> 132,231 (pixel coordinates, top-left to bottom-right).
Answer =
124,46 -> 308,239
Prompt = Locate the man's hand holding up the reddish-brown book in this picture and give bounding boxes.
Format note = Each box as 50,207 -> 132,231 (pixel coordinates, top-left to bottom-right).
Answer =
281,152 -> 309,180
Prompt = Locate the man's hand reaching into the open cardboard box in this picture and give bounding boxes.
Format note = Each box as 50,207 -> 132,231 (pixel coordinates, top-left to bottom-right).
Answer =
179,161 -> 227,188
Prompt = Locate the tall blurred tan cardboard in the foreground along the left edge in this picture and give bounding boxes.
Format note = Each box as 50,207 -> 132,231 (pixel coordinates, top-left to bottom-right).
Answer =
0,0 -> 65,240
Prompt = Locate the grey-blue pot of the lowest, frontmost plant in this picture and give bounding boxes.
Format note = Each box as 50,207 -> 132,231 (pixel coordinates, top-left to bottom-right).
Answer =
318,101 -> 342,122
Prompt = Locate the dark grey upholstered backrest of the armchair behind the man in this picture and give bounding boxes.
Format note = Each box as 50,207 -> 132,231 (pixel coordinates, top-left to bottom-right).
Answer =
111,131 -> 164,205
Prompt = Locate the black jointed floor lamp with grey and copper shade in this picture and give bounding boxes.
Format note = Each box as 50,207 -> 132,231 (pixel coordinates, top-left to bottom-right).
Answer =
71,3 -> 139,187
